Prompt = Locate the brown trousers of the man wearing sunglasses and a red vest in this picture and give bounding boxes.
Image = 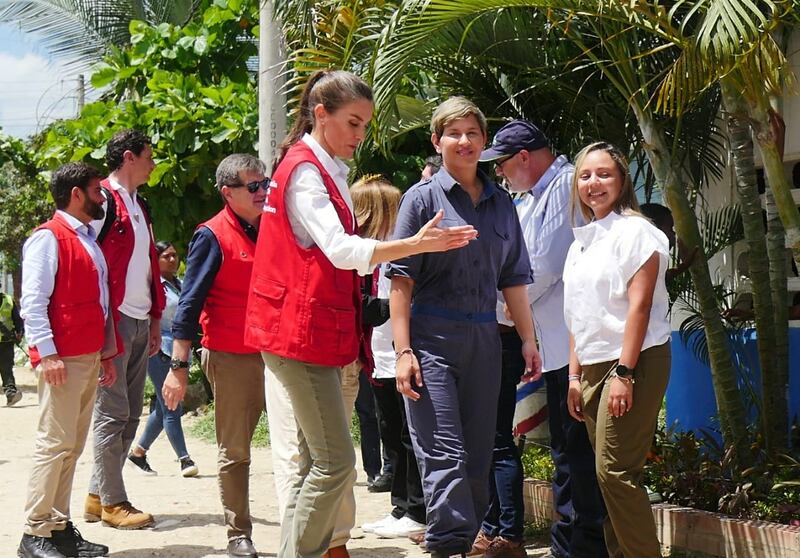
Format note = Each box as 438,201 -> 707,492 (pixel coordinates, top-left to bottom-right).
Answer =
200,349 -> 264,539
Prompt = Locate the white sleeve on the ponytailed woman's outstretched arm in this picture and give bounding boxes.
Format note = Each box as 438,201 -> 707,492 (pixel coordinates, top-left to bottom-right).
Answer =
285,163 -> 378,275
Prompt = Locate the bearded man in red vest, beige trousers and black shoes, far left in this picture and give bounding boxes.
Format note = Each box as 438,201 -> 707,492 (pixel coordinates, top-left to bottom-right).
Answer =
17,163 -> 117,558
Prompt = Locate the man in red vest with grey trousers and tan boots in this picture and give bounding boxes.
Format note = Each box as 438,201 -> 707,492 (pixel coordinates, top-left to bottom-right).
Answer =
84,130 -> 165,529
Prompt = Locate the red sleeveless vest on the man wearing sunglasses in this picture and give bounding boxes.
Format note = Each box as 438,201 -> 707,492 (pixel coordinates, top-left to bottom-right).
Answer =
198,205 -> 257,353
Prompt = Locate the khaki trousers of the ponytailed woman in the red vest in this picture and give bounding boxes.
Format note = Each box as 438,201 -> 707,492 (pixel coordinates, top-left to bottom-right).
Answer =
262,353 -> 356,558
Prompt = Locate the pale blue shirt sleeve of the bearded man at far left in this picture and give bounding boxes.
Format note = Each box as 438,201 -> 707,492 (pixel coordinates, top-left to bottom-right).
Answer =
20,230 -> 58,357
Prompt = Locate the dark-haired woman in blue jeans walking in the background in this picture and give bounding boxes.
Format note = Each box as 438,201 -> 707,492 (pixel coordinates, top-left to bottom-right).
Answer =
128,240 -> 198,477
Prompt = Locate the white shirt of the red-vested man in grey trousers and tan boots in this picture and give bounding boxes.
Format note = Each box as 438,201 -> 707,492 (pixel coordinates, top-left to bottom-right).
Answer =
91,177 -> 153,320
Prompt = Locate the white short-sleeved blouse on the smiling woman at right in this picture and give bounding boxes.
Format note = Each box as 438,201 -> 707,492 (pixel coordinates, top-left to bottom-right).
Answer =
564,212 -> 670,365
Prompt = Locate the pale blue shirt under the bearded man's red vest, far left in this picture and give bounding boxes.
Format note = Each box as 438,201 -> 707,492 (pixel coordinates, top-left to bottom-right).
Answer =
20,210 -> 108,357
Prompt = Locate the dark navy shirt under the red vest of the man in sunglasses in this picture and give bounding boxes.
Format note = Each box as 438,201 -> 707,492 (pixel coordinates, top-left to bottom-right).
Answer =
170,211 -> 258,340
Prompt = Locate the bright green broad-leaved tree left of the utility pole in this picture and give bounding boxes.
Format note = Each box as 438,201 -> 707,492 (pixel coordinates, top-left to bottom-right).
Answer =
0,0 -> 258,251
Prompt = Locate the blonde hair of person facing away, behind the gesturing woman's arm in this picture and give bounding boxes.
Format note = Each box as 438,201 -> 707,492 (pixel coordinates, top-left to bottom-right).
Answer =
350,174 -> 400,240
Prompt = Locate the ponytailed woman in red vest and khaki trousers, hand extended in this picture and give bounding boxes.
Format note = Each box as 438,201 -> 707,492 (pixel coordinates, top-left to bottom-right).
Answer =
245,71 -> 476,558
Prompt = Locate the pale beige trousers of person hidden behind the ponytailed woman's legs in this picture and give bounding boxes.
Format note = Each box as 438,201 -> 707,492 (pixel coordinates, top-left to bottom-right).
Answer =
265,362 -> 361,548
